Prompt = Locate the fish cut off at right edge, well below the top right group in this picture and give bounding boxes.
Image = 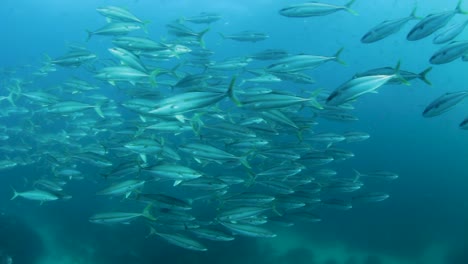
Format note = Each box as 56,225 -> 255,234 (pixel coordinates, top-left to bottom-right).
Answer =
422,91 -> 468,117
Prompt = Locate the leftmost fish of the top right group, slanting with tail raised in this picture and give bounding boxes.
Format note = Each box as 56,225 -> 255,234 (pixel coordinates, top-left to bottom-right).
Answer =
361,7 -> 420,43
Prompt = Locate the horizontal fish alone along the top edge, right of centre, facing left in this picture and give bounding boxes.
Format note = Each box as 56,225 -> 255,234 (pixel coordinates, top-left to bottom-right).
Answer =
279,0 -> 357,17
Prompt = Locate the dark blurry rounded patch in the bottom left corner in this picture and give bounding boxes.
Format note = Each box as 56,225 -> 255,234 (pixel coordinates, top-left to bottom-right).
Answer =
0,215 -> 44,264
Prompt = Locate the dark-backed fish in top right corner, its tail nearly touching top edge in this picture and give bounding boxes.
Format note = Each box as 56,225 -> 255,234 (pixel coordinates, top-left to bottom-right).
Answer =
406,0 -> 468,41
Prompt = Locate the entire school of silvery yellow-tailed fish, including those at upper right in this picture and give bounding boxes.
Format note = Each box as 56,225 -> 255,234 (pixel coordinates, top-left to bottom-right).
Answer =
0,0 -> 468,251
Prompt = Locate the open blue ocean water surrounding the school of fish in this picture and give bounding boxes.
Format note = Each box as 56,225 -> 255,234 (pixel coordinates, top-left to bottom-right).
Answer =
0,0 -> 468,264
